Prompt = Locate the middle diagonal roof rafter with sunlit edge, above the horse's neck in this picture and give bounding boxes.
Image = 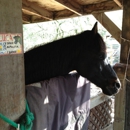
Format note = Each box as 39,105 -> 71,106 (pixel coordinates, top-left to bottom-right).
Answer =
56,0 -> 83,16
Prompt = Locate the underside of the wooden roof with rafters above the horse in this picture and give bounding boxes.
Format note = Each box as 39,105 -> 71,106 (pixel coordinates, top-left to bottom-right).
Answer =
22,0 -> 122,23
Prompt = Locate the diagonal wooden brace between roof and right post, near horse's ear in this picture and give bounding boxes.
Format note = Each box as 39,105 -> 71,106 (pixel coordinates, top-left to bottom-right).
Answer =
93,13 -> 121,43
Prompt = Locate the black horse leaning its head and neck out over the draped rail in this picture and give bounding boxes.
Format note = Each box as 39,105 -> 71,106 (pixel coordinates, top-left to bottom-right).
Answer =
24,23 -> 120,95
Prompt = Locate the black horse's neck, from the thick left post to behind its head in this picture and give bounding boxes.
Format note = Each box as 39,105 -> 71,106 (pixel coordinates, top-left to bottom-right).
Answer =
24,33 -> 80,84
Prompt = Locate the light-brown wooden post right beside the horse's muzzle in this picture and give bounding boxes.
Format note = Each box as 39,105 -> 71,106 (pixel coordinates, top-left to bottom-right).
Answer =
113,63 -> 126,130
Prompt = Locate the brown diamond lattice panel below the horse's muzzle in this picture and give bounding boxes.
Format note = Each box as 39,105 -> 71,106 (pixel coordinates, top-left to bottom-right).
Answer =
88,99 -> 112,130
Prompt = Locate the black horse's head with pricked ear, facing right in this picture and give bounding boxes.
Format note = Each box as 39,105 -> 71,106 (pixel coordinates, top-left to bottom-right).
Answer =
76,23 -> 121,95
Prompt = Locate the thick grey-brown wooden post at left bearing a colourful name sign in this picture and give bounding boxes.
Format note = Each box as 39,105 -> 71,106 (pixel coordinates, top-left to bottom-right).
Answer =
0,0 -> 25,130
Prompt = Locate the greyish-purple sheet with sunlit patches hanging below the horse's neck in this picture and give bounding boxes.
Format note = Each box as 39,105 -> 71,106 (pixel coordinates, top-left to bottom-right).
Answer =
26,73 -> 90,130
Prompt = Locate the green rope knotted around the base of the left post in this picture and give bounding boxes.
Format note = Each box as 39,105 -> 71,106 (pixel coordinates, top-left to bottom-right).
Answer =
0,101 -> 34,130
